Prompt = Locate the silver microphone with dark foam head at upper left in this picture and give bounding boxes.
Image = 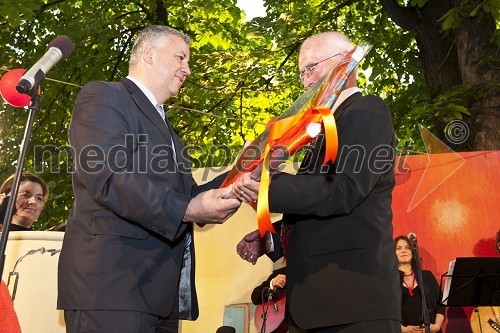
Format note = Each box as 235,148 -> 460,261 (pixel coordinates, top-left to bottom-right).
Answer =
16,35 -> 75,95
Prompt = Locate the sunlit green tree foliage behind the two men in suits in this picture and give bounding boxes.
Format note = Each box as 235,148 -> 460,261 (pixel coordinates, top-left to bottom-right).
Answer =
0,0 -> 498,229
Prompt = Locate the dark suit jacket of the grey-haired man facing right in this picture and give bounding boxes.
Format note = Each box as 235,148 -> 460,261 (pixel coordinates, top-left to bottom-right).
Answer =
58,79 -> 222,319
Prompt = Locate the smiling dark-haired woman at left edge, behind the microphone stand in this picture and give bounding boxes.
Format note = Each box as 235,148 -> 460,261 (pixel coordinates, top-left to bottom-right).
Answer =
0,172 -> 49,231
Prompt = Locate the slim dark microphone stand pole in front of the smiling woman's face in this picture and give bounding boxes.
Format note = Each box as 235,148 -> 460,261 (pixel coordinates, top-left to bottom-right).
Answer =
0,91 -> 40,279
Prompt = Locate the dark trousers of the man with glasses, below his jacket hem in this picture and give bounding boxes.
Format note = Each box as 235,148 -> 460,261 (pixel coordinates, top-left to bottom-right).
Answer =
307,320 -> 401,333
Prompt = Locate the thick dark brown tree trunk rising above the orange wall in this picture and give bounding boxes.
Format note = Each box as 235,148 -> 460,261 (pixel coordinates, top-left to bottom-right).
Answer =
381,0 -> 500,150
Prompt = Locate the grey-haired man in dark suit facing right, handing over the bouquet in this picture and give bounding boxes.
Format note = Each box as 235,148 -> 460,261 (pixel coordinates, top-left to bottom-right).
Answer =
58,26 -> 240,333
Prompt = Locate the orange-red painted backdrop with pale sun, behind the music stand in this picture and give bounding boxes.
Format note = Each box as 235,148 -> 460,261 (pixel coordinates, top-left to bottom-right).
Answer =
392,151 -> 500,333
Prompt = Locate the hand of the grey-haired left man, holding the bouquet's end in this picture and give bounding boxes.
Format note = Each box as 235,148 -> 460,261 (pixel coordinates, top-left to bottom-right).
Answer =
183,186 -> 241,224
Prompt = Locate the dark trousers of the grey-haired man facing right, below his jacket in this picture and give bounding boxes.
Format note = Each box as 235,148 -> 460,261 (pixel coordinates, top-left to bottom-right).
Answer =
64,310 -> 179,333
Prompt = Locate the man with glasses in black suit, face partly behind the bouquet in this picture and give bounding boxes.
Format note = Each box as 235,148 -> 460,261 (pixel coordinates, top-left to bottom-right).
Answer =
233,32 -> 401,333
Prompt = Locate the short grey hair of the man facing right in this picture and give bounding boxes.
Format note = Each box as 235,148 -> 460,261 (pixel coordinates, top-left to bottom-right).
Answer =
129,25 -> 191,66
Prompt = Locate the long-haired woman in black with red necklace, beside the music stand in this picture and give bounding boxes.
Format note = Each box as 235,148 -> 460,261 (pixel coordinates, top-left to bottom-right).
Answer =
394,236 -> 445,333
